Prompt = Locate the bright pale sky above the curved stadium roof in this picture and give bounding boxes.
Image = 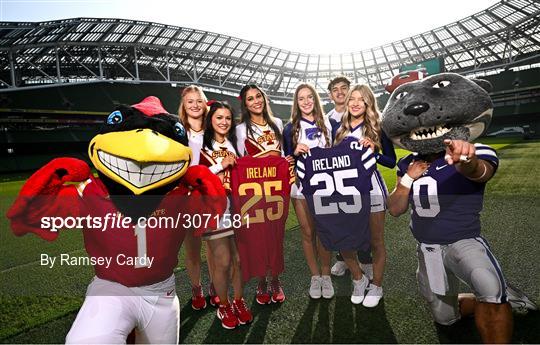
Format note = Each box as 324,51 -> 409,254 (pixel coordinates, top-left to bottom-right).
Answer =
0,0 -> 497,54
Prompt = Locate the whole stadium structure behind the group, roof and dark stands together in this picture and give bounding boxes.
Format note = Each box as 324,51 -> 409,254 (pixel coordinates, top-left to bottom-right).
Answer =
0,0 -> 540,172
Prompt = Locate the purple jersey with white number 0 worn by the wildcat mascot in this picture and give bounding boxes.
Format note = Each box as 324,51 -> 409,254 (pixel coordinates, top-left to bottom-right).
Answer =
397,144 -> 499,244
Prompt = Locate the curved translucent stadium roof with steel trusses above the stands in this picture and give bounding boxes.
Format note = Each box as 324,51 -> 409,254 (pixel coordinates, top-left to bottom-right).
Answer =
0,0 -> 540,100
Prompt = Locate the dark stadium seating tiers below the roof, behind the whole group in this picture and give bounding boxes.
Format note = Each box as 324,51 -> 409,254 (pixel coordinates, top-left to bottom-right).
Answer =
0,68 -> 540,172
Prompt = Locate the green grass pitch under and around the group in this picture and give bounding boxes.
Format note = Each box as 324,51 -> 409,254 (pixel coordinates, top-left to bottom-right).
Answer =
0,139 -> 540,343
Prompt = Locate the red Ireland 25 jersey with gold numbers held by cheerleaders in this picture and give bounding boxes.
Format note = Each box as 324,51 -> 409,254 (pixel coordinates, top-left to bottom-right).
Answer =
231,156 -> 291,281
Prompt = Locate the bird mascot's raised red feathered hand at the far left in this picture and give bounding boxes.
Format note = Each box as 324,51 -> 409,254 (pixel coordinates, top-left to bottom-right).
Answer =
7,158 -> 90,241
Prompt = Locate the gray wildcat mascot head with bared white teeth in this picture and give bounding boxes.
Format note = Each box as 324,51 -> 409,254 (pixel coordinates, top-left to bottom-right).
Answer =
381,73 -> 493,154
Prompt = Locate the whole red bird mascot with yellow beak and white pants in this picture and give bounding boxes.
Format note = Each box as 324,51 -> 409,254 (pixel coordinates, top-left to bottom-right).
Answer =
7,96 -> 225,344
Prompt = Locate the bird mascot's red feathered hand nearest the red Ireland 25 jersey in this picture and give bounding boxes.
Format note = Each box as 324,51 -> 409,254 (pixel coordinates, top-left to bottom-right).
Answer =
172,165 -> 227,236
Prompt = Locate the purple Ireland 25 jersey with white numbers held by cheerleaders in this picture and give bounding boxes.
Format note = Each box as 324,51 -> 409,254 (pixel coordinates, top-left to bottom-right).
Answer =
296,140 -> 376,250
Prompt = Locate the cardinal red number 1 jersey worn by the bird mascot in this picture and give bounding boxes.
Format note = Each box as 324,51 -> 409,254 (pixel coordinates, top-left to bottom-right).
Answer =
78,177 -> 185,287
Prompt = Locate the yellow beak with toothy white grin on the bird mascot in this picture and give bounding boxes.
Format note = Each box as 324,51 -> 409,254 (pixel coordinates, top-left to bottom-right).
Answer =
88,129 -> 192,195
